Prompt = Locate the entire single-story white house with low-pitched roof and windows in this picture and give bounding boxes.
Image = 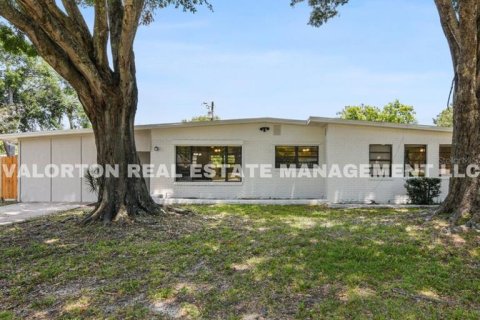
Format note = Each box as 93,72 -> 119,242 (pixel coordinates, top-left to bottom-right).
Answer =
0,117 -> 452,203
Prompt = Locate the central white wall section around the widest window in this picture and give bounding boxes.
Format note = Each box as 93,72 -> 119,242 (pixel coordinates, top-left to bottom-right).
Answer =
151,123 -> 326,199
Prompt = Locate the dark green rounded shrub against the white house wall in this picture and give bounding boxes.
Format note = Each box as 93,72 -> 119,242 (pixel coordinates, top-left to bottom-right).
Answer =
405,177 -> 441,205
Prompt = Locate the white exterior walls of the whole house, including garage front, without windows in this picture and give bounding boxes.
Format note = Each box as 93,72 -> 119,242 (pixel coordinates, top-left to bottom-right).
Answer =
15,122 -> 451,203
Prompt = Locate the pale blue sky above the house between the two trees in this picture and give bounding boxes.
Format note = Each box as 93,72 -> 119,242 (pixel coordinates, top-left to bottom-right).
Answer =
130,0 -> 452,124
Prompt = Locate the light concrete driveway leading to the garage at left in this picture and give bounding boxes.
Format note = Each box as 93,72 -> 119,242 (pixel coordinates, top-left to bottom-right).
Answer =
0,202 -> 84,226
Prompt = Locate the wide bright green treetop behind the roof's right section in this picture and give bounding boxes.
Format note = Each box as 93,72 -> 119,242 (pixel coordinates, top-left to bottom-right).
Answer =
337,100 -> 417,124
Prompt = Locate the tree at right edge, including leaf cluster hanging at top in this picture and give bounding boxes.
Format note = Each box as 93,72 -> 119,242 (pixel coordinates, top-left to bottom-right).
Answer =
291,0 -> 480,227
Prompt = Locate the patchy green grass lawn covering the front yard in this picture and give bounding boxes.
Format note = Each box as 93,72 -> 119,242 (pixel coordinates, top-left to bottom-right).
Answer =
0,206 -> 480,319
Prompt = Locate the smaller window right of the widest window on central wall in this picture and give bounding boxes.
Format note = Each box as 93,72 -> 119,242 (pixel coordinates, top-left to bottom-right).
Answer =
275,146 -> 318,168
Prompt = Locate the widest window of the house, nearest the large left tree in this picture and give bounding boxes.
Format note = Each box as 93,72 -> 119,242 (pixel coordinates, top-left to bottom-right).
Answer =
176,146 -> 242,182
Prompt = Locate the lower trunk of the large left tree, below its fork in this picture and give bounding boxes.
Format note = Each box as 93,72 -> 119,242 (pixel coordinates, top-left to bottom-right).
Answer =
84,89 -> 160,223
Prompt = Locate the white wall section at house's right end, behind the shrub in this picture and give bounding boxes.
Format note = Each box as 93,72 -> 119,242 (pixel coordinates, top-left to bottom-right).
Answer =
326,124 -> 452,203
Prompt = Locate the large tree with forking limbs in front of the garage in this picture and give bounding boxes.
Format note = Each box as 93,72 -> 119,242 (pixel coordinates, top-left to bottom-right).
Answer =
0,0 -> 210,222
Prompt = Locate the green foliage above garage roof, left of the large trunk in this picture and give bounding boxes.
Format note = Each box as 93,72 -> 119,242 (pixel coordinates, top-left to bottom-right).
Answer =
0,41 -> 89,133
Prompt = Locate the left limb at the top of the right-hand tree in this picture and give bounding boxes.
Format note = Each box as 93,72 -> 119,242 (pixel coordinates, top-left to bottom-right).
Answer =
435,0 -> 461,72
